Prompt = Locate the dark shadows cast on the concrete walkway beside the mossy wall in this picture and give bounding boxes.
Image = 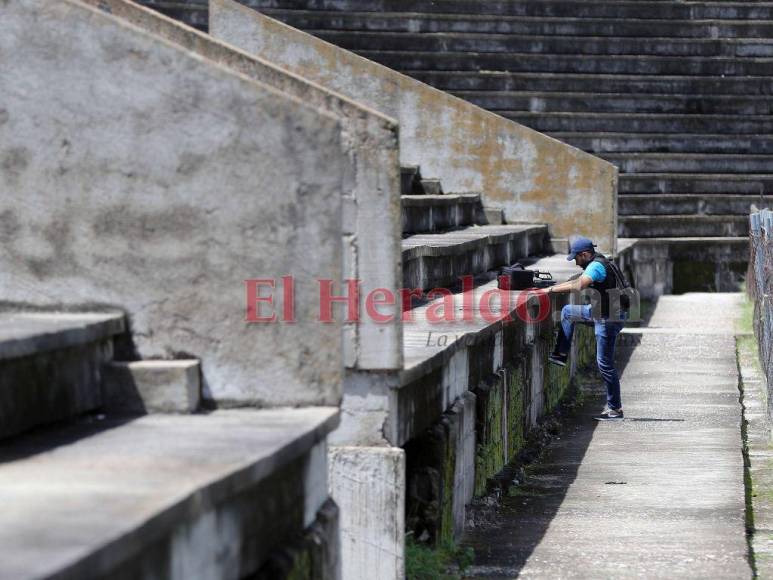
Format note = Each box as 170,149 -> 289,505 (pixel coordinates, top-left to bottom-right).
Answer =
462,300 -> 664,578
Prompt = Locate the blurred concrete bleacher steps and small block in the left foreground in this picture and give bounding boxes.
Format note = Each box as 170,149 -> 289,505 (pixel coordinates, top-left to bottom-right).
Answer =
0,311 -> 337,579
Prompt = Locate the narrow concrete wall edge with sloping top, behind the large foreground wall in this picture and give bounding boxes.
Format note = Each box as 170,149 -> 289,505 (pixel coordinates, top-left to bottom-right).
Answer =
80,0 -> 402,369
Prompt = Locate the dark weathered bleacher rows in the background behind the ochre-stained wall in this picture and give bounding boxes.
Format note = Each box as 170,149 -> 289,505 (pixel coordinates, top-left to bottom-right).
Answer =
223,0 -> 773,259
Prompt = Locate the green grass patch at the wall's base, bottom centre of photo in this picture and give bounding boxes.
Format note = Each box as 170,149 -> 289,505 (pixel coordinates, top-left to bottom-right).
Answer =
405,534 -> 475,580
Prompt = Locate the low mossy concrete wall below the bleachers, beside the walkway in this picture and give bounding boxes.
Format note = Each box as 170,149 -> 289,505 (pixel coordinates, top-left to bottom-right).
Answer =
401,284 -> 595,543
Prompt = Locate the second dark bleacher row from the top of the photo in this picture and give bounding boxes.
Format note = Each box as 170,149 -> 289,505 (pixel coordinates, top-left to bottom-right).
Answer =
261,6 -> 773,38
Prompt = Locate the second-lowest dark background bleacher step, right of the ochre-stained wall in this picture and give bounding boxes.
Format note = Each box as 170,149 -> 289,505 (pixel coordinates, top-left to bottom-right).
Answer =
617,194 -> 773,217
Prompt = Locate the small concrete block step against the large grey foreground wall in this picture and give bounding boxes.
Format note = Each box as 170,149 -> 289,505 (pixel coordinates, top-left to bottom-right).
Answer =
102,360 -> 201,414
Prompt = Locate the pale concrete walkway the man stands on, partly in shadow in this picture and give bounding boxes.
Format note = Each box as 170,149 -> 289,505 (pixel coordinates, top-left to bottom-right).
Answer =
465,294 -> 751,579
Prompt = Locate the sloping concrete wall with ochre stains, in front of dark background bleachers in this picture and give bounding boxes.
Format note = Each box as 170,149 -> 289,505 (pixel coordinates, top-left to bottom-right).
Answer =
209,0 -> 617,253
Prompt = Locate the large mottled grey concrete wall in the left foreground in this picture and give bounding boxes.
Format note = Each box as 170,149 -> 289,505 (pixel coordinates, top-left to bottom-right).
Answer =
0,0 -> 348,405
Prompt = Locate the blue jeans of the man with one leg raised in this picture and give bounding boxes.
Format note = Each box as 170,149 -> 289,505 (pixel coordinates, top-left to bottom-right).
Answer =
556,304 -> 623,409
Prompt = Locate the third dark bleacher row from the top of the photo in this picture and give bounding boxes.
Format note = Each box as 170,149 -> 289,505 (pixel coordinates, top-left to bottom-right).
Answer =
307,29 -> 773,58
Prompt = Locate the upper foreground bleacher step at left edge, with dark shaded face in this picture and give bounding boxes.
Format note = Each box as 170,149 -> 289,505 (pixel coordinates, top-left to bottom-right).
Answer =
0,312 -> 125,439
